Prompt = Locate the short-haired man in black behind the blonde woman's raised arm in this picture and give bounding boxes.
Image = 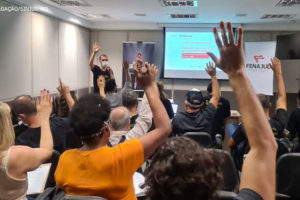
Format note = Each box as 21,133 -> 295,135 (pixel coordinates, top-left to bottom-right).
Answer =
12,81 -> 74,153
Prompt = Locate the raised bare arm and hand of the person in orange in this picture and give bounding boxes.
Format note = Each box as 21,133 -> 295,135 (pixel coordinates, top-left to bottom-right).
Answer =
134,63 -> 172,160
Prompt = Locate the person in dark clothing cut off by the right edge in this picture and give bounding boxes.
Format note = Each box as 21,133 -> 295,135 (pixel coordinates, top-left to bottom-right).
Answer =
287,90 -> 300,152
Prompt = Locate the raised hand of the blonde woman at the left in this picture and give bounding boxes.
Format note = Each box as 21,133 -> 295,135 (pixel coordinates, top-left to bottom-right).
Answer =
36,89 -> 53,121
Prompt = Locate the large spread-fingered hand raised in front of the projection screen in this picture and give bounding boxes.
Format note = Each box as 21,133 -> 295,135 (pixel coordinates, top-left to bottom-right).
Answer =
207,22 -> 245,76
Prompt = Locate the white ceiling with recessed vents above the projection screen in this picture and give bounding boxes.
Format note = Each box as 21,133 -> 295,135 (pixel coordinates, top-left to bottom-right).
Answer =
40,0 -> 300,24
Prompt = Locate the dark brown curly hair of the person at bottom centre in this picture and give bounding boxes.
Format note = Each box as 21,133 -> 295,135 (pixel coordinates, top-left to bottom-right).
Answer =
146,137 -> 223,200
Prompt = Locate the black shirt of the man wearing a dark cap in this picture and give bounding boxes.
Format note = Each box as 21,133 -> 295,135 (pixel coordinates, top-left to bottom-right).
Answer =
172,104 -> 216,135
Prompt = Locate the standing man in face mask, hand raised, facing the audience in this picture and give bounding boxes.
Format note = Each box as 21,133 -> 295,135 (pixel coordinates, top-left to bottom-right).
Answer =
89,43 -> 115,93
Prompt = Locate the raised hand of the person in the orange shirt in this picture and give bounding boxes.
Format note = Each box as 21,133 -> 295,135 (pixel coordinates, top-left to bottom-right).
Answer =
133,62 -> 157,89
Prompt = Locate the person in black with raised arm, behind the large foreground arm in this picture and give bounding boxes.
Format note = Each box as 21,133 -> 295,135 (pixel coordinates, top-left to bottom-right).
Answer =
228,58 -> 288,169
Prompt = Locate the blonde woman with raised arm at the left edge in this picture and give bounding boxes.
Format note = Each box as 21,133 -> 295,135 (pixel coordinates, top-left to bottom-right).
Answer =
0,90 -> 53,200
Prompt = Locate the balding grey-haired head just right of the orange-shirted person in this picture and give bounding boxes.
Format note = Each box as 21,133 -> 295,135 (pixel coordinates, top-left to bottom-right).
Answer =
109,107 -> 130,131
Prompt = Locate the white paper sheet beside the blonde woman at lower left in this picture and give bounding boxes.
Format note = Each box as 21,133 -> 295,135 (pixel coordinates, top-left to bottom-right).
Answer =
27,163 -> 51,195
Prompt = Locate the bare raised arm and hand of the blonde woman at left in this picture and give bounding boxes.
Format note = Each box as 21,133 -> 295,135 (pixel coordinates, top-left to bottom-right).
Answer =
10,90 -> 53,173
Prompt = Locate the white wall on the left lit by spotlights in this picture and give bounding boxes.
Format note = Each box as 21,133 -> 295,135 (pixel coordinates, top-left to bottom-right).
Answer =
0,2 -> 90,100
